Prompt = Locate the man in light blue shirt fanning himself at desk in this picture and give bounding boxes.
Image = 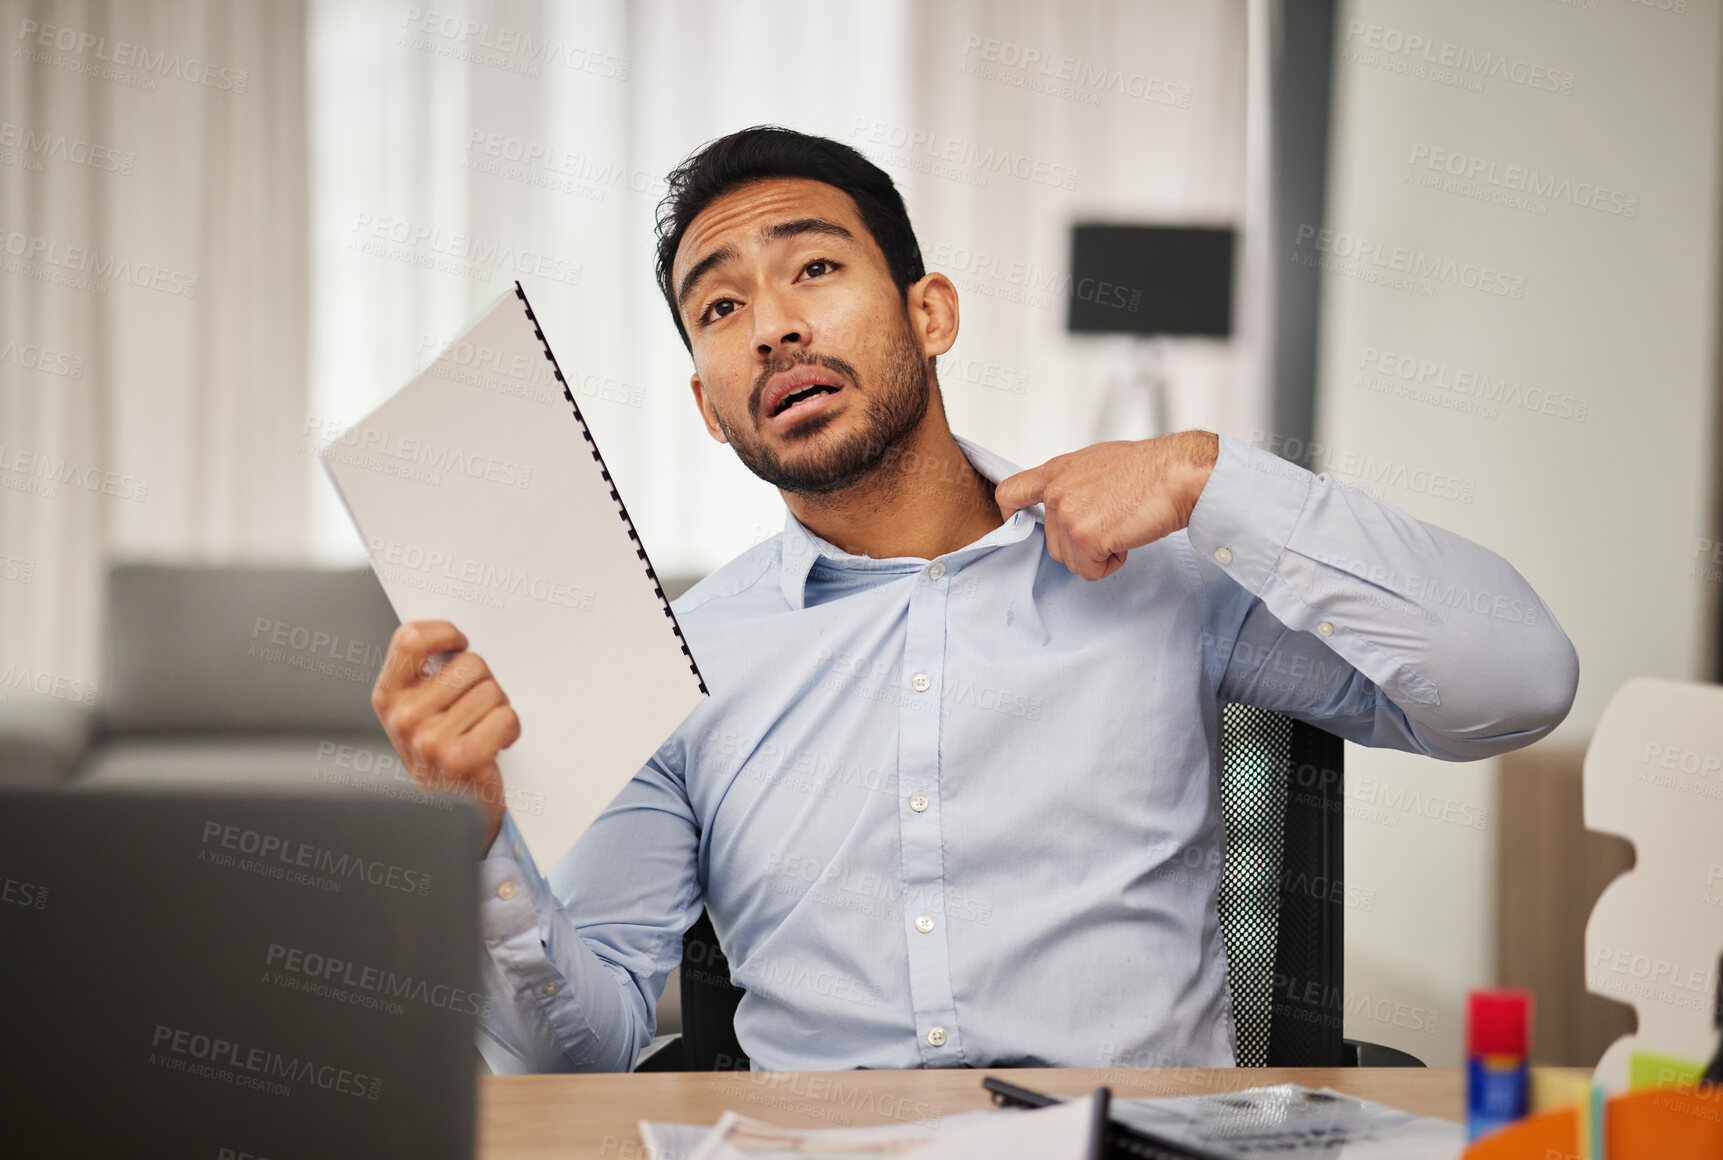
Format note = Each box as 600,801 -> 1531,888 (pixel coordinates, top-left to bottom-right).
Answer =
374,128 -> 1578,1072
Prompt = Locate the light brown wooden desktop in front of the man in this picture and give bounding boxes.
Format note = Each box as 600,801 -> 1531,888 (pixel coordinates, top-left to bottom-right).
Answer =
479,1067 -> 1465,1160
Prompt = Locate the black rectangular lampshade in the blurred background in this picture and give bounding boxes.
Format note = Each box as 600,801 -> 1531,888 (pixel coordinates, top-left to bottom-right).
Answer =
1067,224 -> 1237,338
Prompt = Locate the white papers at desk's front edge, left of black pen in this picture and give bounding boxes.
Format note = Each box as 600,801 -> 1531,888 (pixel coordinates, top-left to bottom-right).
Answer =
665,1096 -> 1094,1160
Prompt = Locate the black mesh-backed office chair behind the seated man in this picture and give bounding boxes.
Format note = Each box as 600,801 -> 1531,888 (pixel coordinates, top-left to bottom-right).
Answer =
636,705 -> 1421,1070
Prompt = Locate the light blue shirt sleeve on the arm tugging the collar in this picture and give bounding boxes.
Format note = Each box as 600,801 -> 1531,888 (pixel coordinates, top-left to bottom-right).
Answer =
1185,436 -> 1578,760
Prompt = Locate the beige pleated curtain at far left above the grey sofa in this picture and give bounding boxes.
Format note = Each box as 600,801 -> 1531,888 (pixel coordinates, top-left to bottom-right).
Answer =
0,0 -> 308,700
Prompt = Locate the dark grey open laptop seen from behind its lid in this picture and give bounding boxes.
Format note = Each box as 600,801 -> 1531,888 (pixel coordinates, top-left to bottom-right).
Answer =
0,789 -> 484,1160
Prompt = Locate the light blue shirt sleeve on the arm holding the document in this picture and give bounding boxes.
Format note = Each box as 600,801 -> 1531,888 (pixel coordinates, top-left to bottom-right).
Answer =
479,752 -> 700,1074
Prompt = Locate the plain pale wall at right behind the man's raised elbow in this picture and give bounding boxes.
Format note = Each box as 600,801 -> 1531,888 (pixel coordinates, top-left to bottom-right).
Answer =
1309,0 -> 1720,1063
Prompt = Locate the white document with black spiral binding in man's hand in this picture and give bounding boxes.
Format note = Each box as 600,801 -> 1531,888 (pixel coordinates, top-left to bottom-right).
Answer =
319,283 -> 706,865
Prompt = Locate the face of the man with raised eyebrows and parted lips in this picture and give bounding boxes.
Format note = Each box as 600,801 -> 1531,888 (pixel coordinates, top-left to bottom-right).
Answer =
672,178 -> 949,495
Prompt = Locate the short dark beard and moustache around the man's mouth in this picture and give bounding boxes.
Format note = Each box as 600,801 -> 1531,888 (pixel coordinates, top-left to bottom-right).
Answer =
718,315 -> 929,495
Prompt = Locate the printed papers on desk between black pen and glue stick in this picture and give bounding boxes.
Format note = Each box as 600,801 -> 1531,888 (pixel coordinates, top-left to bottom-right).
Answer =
1110,1084 -> 1466,1160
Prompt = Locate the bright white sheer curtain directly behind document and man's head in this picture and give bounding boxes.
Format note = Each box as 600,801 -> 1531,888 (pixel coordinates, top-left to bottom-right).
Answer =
307,0 -> 906,574
